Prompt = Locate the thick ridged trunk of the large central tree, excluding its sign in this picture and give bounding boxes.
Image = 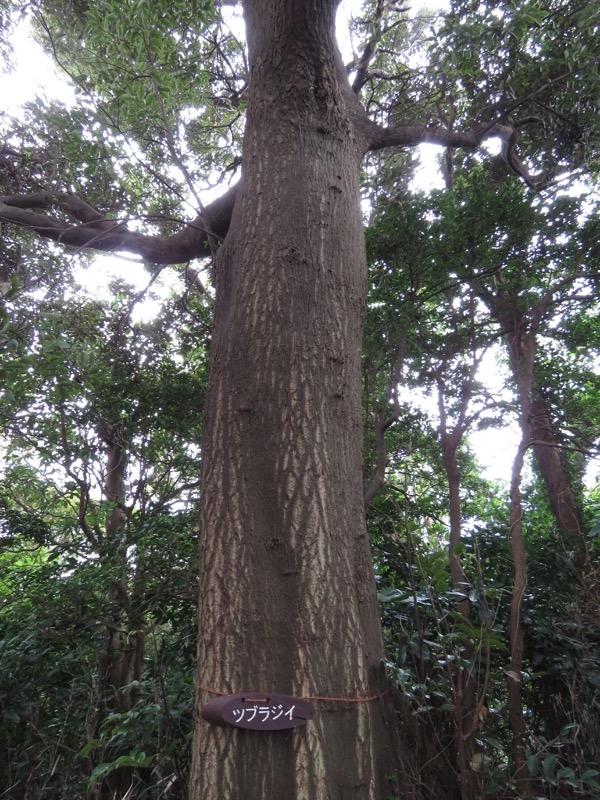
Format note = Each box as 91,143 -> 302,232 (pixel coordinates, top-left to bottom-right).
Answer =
190,0 -> 397,800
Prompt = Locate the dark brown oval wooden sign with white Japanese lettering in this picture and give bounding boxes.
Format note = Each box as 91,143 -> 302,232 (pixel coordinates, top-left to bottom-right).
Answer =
200,692 -> 315,731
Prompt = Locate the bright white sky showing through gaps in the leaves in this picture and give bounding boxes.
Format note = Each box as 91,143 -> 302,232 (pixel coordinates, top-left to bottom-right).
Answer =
0,0 -> 519,481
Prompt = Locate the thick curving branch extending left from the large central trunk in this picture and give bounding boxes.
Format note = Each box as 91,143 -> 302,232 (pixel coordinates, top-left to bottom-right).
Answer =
0,186 -> 236,264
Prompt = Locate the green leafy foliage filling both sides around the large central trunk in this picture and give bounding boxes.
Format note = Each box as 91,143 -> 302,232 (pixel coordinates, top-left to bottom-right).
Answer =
0,0 -> 600,800
